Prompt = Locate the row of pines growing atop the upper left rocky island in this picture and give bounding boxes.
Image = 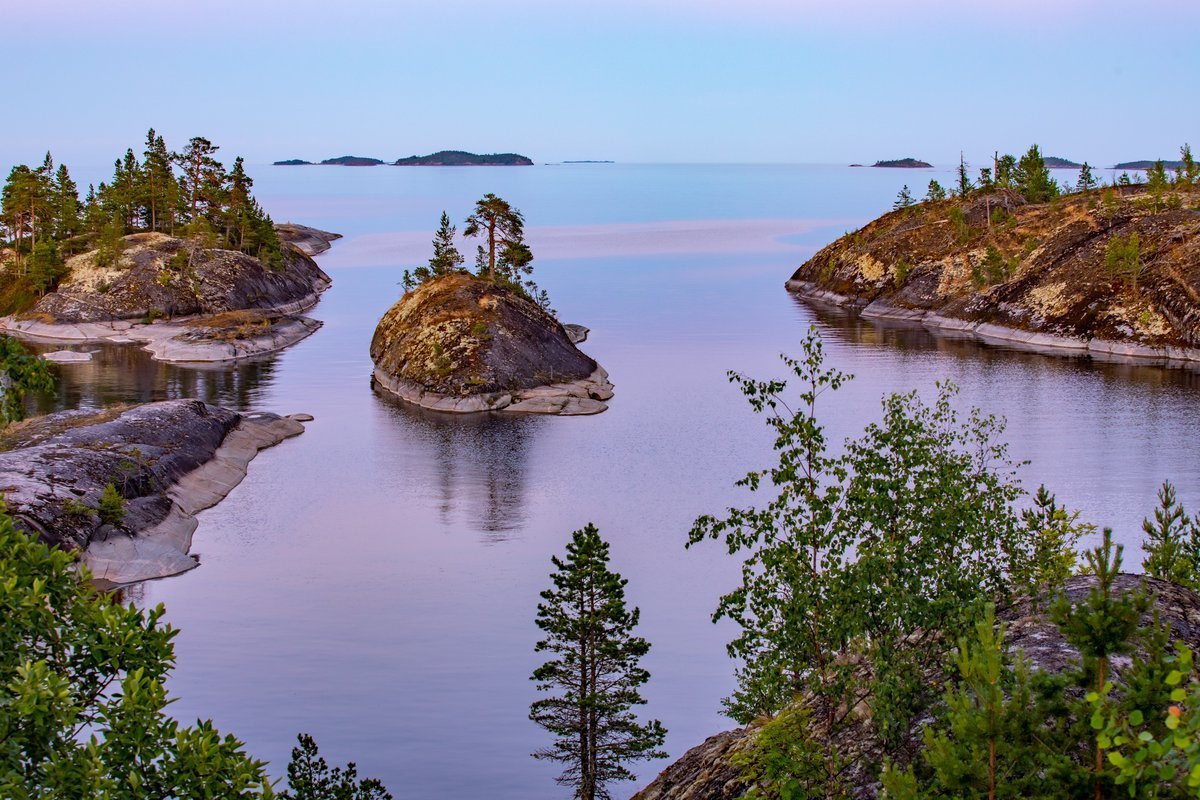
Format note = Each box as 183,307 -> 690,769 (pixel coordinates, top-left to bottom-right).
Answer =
0,128 -> 283,313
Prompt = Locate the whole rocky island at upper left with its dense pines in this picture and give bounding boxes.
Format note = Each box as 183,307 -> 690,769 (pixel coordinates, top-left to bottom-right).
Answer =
0,130 -> 338,361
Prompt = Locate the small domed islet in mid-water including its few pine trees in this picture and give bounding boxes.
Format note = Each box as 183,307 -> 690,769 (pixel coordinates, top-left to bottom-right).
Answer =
371,194 -> 613,416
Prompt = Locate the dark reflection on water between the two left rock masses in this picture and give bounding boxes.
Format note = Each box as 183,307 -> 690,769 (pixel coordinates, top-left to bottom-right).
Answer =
28,343 -> 278,414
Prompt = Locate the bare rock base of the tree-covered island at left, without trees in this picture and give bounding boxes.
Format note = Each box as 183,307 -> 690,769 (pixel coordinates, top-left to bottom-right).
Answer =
0,224 -> 340,362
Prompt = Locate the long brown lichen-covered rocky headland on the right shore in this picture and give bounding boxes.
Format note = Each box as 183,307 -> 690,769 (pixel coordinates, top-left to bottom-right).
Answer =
786,185 -> 1200,363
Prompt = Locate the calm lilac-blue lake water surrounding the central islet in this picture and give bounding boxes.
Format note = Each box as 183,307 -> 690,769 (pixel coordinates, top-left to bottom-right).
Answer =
28,164 -> 1200,799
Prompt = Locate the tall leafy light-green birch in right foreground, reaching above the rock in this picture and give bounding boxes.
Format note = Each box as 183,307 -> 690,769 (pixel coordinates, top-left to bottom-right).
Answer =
689,330 -> 1033,775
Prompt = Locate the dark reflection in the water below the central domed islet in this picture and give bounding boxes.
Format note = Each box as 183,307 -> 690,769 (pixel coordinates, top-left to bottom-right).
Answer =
374,386 -> 544,542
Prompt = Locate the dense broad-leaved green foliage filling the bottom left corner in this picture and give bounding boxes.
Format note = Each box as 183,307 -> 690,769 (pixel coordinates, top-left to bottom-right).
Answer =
0,516 -> 272,800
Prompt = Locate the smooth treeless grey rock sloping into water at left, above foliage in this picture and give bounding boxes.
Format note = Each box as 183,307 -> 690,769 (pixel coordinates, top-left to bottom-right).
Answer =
0,399 -> 312,585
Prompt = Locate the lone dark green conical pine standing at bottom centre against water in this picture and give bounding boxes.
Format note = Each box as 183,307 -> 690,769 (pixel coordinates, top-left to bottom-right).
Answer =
529,524 -> 666,800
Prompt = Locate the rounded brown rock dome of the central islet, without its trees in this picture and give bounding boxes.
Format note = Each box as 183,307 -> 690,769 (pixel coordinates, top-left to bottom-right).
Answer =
371,272 -> 613,415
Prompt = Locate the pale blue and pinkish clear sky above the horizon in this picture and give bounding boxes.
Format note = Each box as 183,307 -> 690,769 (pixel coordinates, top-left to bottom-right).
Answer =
0,0 -> 1200,167
